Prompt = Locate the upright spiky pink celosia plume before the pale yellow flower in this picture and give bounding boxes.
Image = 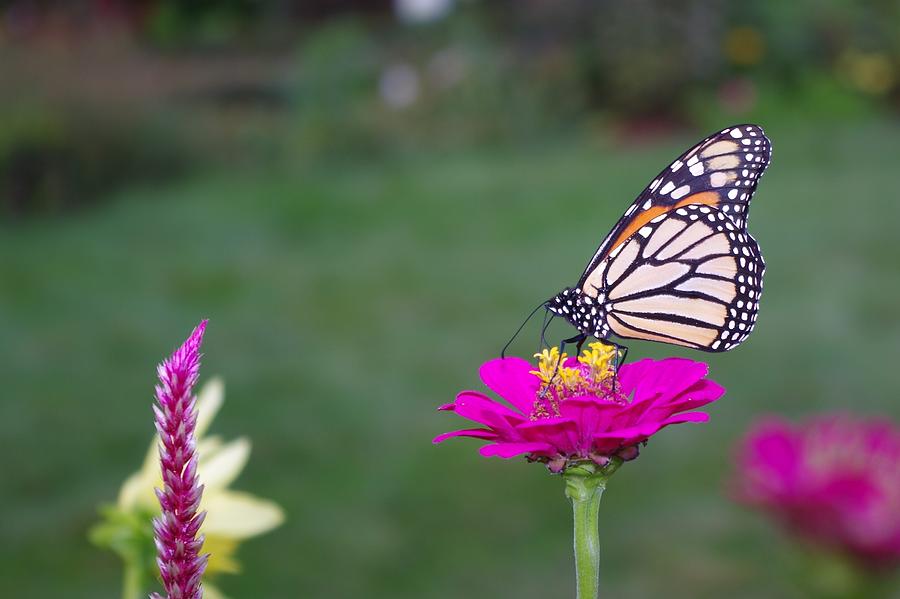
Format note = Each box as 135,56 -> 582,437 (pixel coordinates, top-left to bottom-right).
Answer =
151,320 -> 209,599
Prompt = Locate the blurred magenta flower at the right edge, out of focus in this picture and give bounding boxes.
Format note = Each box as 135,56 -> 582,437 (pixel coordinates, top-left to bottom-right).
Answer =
733,414 -> 900,568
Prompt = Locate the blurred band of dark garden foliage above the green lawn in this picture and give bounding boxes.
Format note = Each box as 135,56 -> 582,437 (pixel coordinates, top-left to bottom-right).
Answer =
0,0 -> 900,214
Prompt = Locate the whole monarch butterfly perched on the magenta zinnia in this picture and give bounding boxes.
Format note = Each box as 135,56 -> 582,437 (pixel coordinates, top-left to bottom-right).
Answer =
545,125 -> 772,352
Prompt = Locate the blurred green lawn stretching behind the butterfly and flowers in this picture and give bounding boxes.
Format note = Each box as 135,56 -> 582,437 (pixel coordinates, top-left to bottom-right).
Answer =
0,123 -> 900,599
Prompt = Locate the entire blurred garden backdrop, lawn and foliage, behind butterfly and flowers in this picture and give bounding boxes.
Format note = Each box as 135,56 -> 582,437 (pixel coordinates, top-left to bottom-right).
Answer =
0,0 -> 900,599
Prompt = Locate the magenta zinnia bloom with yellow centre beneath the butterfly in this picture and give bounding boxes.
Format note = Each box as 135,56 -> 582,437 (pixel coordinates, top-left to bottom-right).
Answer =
434,343 -> 725,472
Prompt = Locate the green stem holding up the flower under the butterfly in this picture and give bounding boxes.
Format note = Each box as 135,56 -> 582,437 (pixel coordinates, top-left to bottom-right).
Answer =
563,458 -> 622,599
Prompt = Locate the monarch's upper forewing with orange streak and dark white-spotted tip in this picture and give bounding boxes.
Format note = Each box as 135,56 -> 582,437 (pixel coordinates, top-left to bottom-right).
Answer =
578,124 -> 772,287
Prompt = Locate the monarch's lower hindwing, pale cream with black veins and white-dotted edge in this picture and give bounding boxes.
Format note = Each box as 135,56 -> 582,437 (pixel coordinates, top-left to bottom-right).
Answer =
581,204 -> 765,352
